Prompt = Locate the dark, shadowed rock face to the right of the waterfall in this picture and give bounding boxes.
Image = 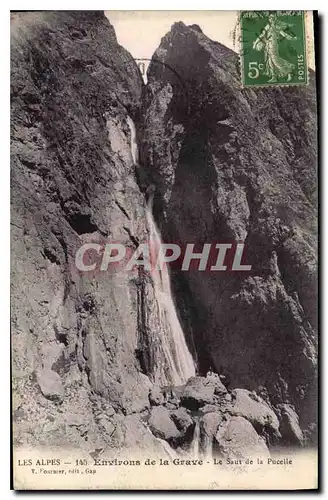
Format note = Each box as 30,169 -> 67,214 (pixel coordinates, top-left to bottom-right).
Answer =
139,23 -> 317,427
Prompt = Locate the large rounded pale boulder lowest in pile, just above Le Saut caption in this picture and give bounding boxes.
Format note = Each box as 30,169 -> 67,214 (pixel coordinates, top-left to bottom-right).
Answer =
215,417 -> 270,460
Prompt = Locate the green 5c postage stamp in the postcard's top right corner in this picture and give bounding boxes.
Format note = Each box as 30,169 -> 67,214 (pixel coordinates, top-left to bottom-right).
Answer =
240,10 -> 308,87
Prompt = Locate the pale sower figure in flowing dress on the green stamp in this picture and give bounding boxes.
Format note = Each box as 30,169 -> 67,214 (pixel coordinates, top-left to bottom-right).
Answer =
253,14 -> 297,83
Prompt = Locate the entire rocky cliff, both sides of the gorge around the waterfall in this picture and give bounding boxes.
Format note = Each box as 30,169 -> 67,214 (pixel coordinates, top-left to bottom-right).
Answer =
11,11 -> 316,456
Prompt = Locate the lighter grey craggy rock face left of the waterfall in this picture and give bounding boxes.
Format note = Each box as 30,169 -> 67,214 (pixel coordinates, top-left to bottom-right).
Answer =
11,11 -> 165,449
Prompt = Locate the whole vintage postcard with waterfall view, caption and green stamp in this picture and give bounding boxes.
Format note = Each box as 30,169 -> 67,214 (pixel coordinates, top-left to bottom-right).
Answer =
10,9 -> 318,490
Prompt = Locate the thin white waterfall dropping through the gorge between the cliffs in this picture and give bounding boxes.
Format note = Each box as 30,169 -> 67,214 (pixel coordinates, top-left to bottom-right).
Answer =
127,117 -> 195,386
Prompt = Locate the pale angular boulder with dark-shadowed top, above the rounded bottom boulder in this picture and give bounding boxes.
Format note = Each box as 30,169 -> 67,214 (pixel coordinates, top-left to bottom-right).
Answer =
229,389 -> 280,436
